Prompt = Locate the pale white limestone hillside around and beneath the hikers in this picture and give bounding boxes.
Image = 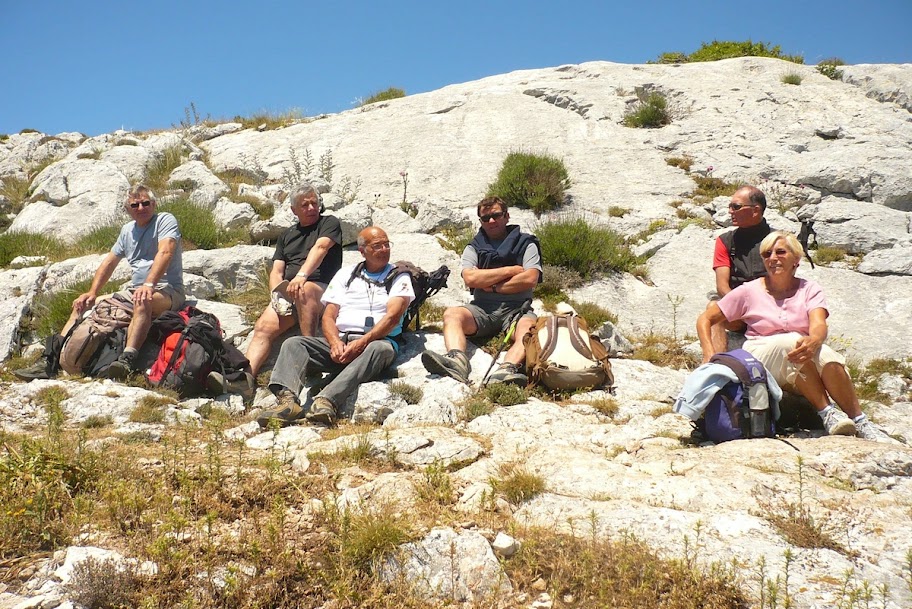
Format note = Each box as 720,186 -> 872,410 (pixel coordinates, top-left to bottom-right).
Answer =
0,58 -> 912,607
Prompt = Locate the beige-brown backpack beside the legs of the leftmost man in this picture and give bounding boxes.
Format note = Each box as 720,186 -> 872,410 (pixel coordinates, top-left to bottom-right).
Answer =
60,294 -> 133,374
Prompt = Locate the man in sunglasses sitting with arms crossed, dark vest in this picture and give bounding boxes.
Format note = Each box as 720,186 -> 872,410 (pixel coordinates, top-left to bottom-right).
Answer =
421,197 -> 542,385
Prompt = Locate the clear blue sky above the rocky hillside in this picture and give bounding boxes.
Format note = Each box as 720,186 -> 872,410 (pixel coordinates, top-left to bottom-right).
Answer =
0,0 -> 912,135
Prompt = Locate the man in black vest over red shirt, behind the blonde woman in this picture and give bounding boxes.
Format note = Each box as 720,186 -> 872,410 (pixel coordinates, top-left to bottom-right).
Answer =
711,186 -> 772,353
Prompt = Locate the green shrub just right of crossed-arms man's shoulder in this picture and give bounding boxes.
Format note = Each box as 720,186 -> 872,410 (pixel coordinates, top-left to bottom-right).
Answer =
535,218 -> 640,280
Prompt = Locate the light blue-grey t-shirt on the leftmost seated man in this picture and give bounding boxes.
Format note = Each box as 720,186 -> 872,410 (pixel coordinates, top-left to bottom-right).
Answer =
111,212 -> 184,288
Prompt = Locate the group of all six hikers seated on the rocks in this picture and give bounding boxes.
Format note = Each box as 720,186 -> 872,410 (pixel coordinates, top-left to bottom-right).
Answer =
16,182 -> 886,440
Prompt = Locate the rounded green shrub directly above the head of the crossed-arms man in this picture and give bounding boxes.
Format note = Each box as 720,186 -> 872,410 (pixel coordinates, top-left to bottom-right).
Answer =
488,152 -> 570,216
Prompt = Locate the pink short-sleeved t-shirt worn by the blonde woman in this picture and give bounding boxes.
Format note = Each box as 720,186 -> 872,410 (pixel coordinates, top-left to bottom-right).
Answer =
719,279 -> 829,338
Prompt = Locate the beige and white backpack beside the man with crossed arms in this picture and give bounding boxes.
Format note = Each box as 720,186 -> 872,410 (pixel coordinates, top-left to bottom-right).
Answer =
523,311 -> 614,390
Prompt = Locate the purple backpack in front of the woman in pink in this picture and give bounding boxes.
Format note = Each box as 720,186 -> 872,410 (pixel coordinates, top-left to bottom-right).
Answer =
704,349 -> 776,443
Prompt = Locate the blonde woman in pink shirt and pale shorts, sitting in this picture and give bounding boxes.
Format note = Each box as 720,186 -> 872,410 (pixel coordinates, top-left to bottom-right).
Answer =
697,231 -> 891,441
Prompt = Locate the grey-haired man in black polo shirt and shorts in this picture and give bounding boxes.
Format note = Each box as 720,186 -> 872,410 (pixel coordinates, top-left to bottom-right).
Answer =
246,182 -> 342,376
